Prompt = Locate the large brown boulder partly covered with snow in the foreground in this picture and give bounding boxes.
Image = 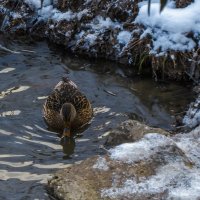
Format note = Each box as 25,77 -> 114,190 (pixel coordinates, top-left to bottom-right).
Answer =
48,121 -> 200,200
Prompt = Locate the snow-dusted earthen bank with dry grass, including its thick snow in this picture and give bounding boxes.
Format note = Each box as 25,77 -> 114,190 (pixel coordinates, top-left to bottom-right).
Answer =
0,0 -> 200,82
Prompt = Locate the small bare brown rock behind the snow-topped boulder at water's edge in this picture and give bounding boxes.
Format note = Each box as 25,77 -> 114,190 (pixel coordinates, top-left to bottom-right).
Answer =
105,120 -> 170,146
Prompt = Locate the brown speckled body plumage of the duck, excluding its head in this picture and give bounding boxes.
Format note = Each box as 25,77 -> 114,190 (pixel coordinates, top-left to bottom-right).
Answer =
44,78 -> 93,131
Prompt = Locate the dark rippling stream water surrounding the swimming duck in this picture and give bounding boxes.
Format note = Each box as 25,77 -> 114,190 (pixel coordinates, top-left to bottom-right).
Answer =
0,41 -> 192,200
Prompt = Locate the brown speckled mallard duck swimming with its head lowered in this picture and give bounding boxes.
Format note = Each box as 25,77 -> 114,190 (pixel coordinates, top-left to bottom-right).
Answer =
43,77 -> 93,137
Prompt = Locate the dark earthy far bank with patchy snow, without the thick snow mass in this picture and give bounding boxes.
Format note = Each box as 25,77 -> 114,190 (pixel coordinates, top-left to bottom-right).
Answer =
0,0 -> 199,83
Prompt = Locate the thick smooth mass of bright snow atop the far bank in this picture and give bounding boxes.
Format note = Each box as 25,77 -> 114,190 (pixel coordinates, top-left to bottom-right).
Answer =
135,0 -> 200,54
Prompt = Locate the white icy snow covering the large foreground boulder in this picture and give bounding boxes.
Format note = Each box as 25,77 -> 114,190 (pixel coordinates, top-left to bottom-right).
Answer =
101,126 -> 200,200
